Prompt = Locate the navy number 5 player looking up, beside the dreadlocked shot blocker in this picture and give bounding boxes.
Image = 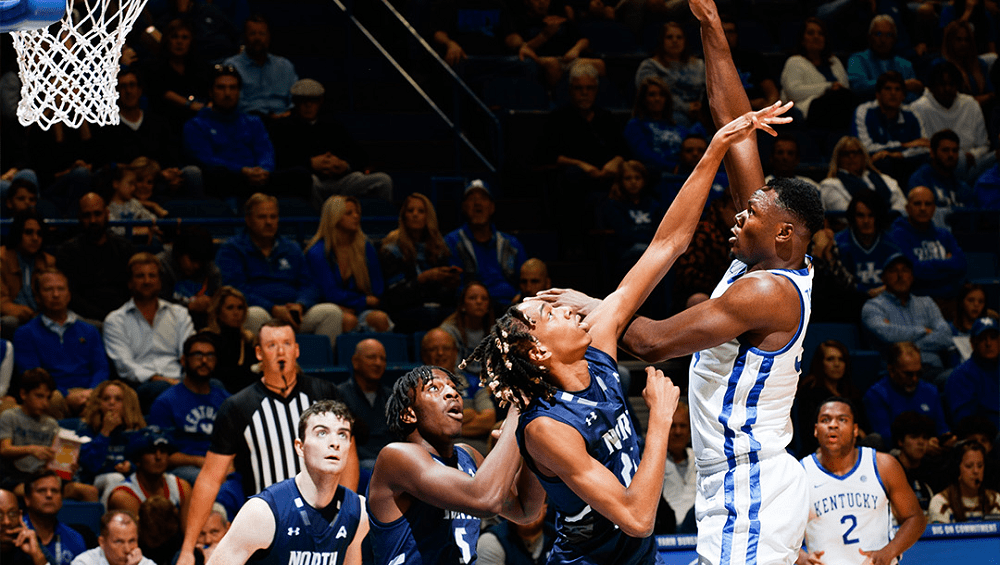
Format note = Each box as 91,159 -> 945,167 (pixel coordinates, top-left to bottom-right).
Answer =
368,365 -> 544,565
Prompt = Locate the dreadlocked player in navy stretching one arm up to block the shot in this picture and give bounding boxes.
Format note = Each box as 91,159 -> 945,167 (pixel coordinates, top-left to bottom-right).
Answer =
460,100 -> 794,565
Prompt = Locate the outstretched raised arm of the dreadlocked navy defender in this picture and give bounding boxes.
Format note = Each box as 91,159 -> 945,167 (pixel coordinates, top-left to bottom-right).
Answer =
587,102 -> 791,352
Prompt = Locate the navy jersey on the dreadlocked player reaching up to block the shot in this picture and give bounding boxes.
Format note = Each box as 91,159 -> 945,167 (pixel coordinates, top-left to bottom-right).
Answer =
517,347 -> 657,565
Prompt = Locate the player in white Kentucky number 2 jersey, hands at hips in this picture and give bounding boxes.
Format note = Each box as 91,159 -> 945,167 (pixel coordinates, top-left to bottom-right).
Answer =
796,398 -> 927,565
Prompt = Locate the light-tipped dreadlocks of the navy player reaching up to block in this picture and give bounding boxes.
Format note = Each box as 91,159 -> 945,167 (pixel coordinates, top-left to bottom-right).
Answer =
458,305 -> 556,410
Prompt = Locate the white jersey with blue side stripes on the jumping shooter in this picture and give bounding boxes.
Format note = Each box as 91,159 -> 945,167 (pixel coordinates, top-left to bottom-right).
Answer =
688,256 -> 813,473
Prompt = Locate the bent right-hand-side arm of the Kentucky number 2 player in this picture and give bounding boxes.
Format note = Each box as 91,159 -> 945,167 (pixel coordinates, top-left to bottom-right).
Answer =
858,453 -> 927,565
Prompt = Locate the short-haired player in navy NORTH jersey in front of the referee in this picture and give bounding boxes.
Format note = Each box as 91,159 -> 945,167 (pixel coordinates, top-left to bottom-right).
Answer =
208,400 -> 368,565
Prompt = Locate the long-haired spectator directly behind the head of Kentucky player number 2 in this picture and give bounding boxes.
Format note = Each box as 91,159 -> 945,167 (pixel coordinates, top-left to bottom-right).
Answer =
795,339 -> 868,454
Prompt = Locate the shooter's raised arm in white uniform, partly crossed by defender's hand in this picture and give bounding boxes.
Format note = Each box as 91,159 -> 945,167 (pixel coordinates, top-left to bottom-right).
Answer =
689,0 -> 764,205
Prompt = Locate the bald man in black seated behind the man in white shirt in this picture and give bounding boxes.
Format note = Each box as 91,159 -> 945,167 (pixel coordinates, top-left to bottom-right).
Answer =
56,192 -> 133,325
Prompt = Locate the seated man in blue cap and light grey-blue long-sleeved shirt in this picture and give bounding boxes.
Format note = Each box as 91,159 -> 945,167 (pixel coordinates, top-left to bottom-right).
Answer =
861,254 -> 951,374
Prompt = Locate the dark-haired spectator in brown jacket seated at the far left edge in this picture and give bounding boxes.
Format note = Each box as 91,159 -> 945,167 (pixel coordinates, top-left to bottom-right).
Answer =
0,210 -> 56,331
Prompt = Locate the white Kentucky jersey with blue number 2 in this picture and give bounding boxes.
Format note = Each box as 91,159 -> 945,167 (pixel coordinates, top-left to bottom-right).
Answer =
802,447 -> 892,565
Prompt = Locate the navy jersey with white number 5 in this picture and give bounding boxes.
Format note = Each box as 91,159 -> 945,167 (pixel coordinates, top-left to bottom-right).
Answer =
368,447 -> 479,565
